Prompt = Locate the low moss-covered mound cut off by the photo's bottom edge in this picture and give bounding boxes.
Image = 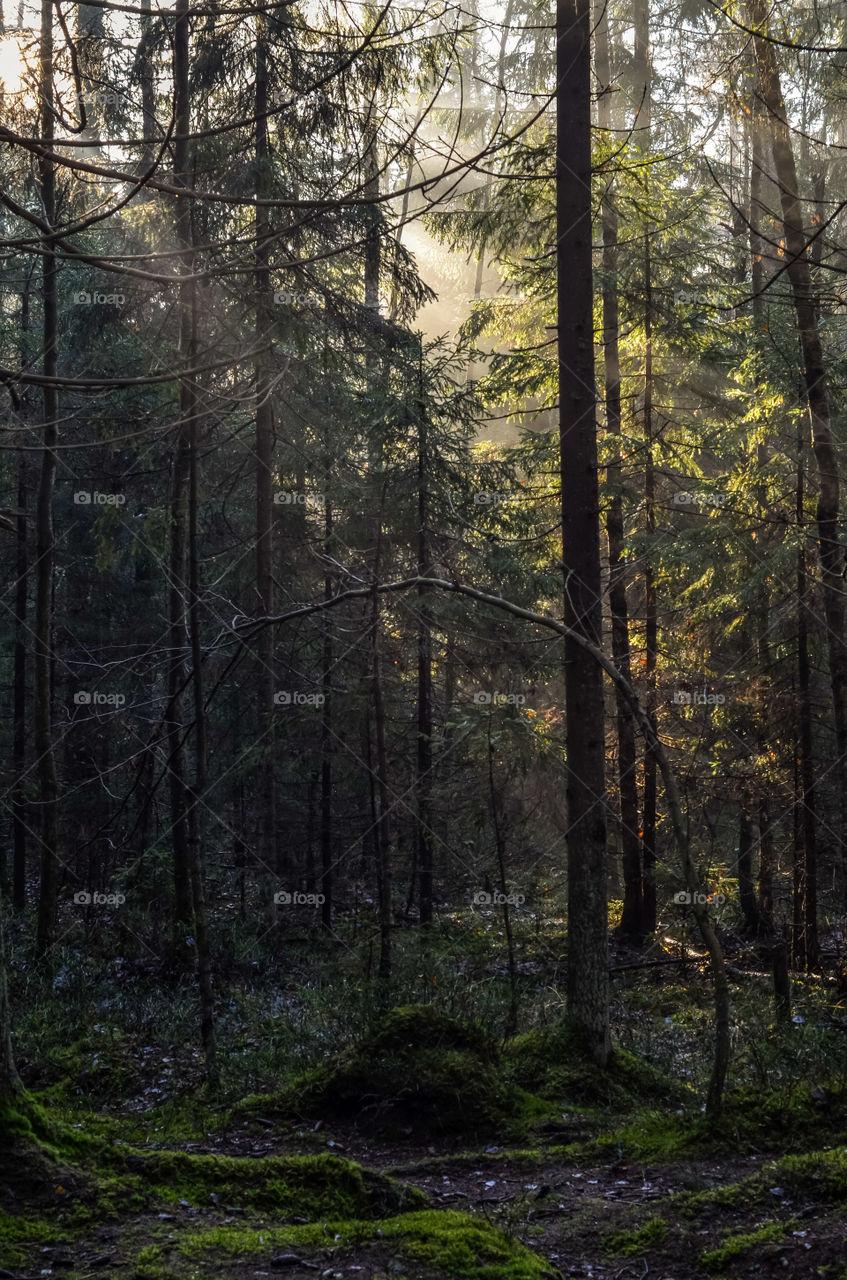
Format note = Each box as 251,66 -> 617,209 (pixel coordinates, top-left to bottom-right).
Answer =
134,1210 -> 551,1280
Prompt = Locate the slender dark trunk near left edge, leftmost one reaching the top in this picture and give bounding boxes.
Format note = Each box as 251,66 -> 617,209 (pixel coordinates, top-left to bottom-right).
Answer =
33,0 -> 59,955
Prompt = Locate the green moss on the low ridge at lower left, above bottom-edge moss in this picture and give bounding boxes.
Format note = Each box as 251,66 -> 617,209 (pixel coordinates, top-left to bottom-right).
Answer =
131,1152 -> 426,1219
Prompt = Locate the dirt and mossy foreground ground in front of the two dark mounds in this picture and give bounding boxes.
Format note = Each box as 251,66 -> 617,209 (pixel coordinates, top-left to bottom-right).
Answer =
0,1059 -> 847,1280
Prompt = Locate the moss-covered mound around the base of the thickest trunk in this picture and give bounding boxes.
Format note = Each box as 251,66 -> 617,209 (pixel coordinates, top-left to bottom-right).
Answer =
503,1021 -> 690,1111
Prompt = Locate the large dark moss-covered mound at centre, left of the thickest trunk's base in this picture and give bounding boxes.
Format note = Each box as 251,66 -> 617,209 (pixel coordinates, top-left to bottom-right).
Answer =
236,1005 -> 544,1139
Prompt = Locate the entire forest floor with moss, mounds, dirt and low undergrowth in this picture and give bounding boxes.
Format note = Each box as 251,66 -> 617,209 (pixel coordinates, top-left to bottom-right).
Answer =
0,921 -> 847,1280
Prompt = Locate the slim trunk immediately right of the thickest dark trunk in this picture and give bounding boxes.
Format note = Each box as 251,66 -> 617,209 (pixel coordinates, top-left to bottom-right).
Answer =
594,3 -> 644,942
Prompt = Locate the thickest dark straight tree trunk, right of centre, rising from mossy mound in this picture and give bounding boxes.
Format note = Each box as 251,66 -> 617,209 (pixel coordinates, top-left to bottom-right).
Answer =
557,0 -> 609,1065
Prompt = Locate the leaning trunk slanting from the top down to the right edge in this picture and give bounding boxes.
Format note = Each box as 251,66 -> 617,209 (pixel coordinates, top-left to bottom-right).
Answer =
750,0 -> 847,890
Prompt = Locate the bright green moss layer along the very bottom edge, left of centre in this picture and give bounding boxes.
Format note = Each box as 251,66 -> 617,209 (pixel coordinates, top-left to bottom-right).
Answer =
136,1210 -> 549,1280
